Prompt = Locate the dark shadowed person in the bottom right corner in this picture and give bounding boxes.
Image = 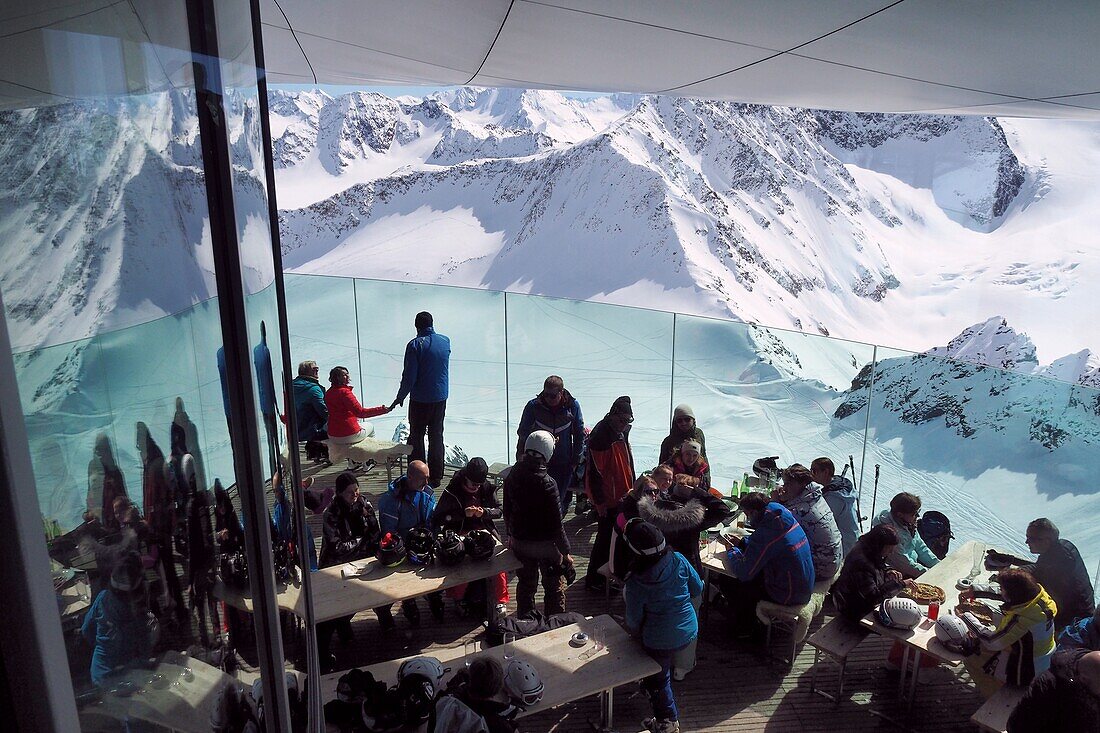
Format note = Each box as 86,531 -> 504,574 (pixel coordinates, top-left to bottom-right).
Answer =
1008,649 -> 1100,733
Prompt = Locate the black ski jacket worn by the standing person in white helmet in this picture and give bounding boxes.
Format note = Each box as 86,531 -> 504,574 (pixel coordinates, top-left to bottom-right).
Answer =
504,456 -> 570,555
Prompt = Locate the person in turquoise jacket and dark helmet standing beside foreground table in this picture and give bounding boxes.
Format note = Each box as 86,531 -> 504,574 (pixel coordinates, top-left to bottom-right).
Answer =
623,517 -> 703,733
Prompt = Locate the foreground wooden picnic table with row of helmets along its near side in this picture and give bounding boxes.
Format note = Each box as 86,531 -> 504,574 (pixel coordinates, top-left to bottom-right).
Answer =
320,615 -> 661,730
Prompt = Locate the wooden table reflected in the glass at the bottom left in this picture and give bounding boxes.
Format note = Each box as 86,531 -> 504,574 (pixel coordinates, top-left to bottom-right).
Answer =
79,654 -> 235,733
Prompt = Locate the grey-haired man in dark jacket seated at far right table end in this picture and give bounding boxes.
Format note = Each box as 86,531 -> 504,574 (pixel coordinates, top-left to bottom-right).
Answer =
990,518 -> 1096,628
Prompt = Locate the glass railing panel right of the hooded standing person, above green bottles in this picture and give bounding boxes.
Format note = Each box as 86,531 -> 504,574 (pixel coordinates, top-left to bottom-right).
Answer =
674,316 -> 873,493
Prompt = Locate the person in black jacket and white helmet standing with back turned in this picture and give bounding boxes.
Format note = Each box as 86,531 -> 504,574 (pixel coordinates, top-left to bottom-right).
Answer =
504,430 -> 573,616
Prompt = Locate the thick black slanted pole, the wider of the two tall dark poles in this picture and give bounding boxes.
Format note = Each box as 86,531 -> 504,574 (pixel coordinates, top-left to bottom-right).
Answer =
187,0 -> 290,731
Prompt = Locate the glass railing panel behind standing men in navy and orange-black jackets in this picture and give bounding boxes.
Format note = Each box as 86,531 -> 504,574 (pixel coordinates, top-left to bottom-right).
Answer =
507,293 -> 673,473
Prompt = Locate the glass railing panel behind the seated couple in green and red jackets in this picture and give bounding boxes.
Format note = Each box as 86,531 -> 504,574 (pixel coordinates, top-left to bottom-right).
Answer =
283,274 -> 363,392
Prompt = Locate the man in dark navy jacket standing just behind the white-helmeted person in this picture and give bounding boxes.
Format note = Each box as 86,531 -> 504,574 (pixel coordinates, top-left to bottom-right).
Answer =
516,374 -> 584,516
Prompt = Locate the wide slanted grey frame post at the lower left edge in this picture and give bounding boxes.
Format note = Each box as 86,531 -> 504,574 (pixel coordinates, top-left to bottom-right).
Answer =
0,288 -> 80,733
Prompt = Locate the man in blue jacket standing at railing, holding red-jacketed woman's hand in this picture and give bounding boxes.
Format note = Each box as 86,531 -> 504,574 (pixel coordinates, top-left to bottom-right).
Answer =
389,310 -> 451,488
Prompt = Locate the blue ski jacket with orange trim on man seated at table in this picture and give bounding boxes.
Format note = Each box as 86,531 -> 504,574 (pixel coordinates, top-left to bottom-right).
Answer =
726,502 -> 815,605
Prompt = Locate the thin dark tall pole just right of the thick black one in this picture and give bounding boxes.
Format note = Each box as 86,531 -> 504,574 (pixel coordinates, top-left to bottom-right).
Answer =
251,0 -> 321,731
